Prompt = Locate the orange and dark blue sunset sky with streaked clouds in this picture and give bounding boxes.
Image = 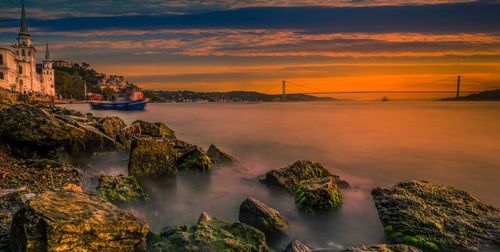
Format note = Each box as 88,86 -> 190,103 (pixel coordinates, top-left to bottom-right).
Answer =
0,0 -> 500,97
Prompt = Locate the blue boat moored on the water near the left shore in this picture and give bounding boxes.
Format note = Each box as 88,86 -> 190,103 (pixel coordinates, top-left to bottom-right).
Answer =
90,89 -> 149,110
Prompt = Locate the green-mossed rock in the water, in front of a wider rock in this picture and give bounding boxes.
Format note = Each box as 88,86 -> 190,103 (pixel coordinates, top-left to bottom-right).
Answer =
295,177 -> 342,214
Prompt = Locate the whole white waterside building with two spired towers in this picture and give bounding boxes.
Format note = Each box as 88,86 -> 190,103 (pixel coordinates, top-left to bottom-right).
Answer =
0,1 -> 55,96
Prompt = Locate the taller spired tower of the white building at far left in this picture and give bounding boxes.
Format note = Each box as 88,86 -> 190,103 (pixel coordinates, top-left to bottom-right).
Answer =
14,1 -> 37,93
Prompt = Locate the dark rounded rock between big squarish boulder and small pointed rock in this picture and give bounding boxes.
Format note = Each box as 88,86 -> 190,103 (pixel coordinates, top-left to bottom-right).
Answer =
177,147 -> 213,172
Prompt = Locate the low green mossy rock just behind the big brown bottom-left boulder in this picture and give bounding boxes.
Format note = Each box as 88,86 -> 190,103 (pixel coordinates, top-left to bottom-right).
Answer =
96,175 -> 148,203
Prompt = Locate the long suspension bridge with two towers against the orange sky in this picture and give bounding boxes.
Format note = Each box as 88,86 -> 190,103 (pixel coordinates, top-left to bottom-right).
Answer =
262,75 -> 500,101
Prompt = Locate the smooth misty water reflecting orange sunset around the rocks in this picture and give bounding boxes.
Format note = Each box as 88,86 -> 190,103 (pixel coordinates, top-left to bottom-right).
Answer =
63,102 -> 500,248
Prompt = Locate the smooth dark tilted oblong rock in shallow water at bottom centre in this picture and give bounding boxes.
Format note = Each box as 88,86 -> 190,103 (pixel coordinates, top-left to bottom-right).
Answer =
239,197 -> 288,239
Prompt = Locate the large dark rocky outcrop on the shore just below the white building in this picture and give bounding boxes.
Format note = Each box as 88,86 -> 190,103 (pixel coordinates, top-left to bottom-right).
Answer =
0,104 -> 120,158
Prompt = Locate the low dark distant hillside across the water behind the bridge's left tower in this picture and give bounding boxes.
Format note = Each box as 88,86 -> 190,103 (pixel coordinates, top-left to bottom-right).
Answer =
144,90 -> 333,102
